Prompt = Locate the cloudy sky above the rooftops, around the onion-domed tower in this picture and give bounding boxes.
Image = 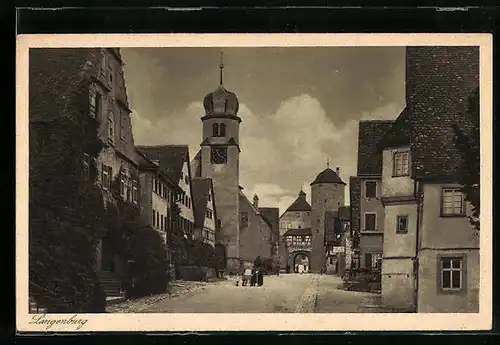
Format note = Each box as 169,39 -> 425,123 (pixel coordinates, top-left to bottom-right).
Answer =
121,47 -> 405,214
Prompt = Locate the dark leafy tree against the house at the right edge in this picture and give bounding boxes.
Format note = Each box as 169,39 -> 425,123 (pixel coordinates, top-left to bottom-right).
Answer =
454,88 -> 480,231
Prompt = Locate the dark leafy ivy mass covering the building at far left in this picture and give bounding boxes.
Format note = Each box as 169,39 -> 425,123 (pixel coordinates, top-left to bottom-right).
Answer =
29,77 -> 105,313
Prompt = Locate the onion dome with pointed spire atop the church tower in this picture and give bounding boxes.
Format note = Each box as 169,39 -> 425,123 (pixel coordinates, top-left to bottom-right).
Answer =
203,51 -> 240,116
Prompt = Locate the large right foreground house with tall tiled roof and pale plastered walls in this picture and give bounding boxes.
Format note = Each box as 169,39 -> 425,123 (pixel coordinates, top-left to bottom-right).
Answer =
379,47 -> 480,312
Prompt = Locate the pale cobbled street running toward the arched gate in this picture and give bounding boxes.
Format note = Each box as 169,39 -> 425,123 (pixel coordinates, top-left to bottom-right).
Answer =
114,274 -> 380,313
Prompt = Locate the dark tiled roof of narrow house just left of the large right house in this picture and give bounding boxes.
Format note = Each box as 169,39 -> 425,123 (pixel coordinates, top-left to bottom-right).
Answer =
357,120 -> 394,176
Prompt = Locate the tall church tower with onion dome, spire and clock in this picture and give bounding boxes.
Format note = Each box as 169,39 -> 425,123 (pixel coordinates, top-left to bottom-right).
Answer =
200,54 -> 241,271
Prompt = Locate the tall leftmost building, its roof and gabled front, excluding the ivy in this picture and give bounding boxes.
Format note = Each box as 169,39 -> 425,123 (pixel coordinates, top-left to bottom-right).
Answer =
30,48 -> 140,295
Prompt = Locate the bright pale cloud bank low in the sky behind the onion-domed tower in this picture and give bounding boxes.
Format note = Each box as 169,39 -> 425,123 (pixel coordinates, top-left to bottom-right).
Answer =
132,93 -> 400,214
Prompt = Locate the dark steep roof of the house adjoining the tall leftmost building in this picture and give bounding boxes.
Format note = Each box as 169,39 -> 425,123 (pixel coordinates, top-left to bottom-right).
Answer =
136,145 -> 189,183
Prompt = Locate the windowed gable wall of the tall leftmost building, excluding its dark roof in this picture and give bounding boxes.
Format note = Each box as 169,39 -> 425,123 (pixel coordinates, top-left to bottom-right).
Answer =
89,48 -> 140,279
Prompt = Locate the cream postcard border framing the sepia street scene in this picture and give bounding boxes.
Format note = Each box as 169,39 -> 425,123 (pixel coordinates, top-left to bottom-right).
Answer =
16,33 -> 493,332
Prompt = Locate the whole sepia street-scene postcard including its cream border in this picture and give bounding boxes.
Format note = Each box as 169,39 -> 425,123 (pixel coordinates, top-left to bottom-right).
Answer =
17,35 -> 492,331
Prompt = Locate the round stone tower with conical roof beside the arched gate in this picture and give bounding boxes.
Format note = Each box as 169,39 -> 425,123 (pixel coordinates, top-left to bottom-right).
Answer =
310,162 -> 346,273
